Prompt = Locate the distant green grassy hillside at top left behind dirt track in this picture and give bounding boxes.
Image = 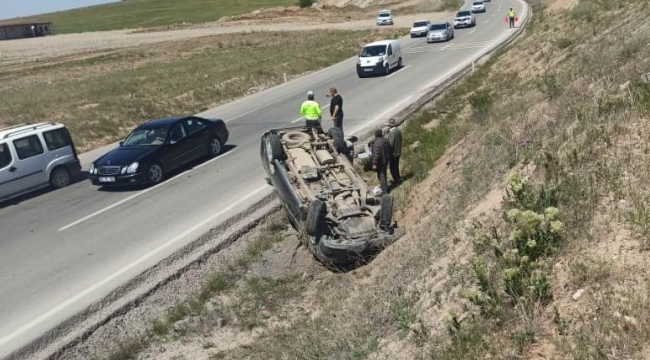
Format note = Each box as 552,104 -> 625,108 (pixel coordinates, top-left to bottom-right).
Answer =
0,0 -> 296,34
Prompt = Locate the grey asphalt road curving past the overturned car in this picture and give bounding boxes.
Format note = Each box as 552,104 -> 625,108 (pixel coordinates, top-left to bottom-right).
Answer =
0,0 -> 525,357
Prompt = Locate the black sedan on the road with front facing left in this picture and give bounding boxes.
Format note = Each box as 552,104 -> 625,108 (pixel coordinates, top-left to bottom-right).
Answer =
88,116 -> 228,186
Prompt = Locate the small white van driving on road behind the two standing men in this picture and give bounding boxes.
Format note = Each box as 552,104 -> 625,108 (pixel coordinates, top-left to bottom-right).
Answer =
357,40 -> 402,77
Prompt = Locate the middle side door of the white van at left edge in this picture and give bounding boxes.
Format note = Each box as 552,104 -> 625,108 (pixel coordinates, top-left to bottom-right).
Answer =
10,134 -> 49,191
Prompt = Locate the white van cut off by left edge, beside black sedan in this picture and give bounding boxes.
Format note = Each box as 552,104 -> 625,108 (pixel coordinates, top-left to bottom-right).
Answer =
0,123 -> 81,201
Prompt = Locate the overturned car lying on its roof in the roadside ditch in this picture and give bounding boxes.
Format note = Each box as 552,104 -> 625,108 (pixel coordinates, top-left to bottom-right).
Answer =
260,127 -> 397,266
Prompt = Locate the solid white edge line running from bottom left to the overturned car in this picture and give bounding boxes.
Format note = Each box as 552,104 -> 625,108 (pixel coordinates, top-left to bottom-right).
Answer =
0,185 -> 268,346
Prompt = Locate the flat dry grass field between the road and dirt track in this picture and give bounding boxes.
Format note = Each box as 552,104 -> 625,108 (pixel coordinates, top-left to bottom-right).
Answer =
0,30 -> 397,150
